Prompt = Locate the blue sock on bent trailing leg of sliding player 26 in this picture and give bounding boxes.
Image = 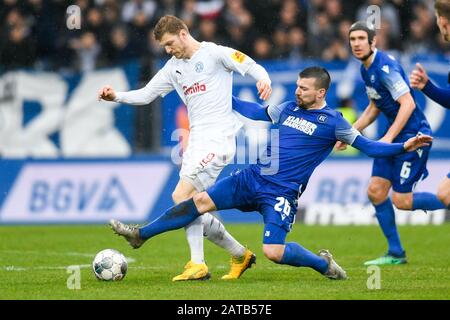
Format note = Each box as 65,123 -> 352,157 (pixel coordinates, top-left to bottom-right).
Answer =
279,242 -> 328,274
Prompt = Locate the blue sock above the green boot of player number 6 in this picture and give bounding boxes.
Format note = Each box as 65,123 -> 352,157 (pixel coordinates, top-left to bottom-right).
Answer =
374,198 -> 405,257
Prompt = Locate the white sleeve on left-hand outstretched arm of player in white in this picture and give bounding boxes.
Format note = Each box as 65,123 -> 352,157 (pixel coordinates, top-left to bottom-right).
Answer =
114,61 -> 174,105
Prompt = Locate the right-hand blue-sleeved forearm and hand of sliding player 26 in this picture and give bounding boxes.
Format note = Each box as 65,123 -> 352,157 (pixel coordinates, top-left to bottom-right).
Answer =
352,135 -> 433,158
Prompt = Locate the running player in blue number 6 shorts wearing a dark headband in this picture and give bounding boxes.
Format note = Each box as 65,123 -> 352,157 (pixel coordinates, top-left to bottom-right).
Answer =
337,21 -> 444,265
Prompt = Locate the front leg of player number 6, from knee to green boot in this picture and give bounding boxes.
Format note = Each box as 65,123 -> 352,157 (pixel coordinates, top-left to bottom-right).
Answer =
364,177 -> 406,265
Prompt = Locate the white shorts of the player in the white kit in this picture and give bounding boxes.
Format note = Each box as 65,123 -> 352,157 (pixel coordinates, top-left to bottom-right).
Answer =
180,135 -> 236,192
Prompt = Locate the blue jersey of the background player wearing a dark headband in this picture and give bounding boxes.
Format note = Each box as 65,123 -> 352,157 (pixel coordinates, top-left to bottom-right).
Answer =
361,50 -> 432,142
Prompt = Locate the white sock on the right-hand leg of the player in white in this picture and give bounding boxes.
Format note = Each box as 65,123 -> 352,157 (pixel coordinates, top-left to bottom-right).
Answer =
203,212 -> 245,257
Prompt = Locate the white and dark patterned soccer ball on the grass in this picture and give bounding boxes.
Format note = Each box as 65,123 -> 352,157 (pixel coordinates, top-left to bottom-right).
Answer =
92,249 -> 128,281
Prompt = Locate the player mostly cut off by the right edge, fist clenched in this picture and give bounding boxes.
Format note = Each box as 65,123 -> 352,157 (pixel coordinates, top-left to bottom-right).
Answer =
409,0 -> 450,209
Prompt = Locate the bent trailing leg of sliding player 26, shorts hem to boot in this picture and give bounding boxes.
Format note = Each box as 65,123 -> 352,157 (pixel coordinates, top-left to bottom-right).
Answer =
263,223 -> 347,280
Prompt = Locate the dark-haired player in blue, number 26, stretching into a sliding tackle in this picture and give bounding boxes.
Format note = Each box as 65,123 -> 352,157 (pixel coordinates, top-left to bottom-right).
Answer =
110,67 -> 431,279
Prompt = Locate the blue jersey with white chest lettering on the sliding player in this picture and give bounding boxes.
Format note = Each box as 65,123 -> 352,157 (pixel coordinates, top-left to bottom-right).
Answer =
253,101 -> 360,192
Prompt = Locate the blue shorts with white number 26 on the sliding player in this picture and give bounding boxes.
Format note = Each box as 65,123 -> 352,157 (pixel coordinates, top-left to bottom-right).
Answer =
206,167 -> 298,244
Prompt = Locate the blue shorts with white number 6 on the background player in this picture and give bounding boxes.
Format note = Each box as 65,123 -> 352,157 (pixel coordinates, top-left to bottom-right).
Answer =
372,146 -> 431,193
